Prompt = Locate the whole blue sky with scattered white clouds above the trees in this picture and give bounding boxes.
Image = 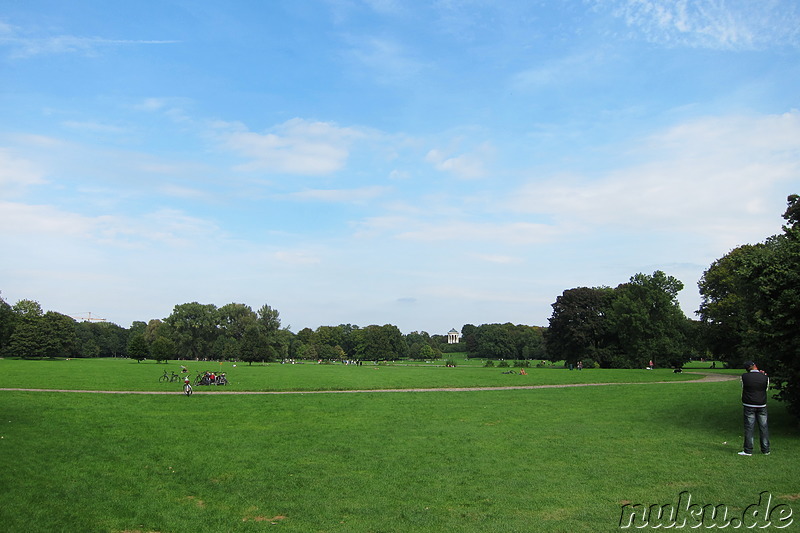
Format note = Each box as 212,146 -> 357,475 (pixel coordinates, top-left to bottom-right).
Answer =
0,0 -> 800,333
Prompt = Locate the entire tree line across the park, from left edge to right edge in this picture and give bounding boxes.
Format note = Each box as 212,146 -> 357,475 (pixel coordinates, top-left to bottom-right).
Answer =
0,195 -> 800,415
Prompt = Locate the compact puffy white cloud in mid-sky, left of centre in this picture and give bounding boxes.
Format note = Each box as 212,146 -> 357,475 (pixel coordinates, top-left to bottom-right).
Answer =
217,118 -> 363,176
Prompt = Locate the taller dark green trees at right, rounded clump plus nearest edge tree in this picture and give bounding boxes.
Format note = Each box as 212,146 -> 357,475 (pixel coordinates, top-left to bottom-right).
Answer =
544,194 -> 800,418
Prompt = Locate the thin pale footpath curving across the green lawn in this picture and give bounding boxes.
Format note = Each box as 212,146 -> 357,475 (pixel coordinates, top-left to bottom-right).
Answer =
0,372 -> 739,394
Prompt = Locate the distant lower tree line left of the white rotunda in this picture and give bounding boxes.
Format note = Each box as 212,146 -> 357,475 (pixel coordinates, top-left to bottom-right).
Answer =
0,298 -> 453,363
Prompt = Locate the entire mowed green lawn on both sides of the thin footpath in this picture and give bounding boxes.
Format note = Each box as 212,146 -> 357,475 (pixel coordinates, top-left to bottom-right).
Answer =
0,360 -> 800,533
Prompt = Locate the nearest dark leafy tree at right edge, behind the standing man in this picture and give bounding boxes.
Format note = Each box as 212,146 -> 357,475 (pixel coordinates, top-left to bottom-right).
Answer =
698,194 -> 800,417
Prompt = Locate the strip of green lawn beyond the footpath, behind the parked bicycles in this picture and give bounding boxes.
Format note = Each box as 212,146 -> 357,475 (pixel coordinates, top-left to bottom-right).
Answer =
0,359 -> 704,392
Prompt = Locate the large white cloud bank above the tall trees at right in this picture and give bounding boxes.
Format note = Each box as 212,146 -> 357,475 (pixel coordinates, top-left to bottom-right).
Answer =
509,112 -> 800,249
